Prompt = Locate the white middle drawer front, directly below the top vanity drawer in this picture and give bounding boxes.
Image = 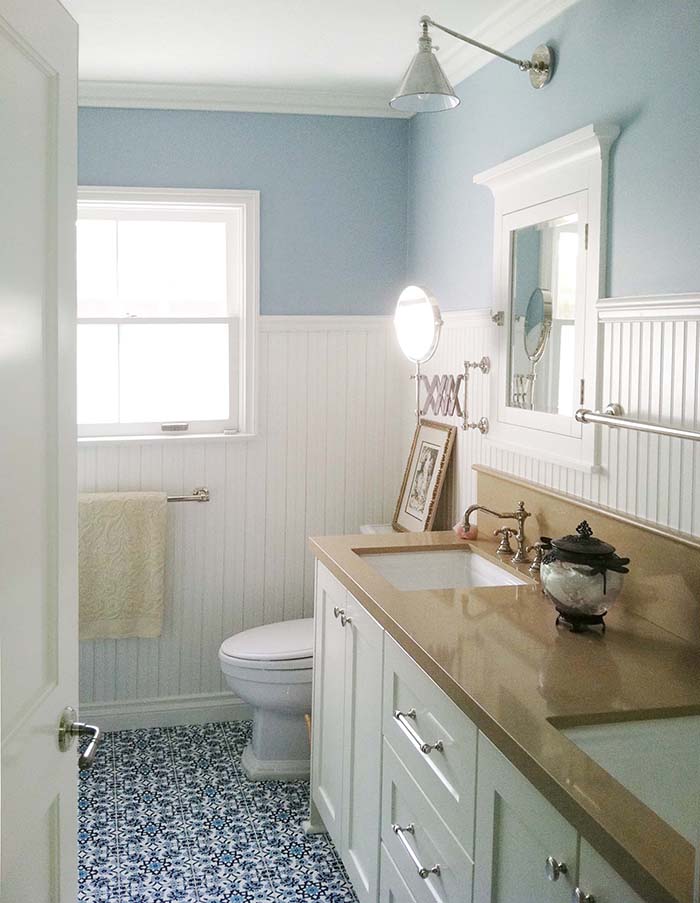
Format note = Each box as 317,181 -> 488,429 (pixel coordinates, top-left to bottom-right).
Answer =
382,740 -> 474,903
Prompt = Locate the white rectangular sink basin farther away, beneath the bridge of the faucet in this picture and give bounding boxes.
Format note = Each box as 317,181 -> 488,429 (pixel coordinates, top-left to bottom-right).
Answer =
362,549 -> 527,590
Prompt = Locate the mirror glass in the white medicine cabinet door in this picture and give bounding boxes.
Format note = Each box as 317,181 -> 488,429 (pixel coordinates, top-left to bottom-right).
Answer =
508,214 -> 579,415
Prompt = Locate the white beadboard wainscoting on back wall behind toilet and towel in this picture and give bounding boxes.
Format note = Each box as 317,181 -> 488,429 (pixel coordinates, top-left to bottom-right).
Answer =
78,316 -> 410,729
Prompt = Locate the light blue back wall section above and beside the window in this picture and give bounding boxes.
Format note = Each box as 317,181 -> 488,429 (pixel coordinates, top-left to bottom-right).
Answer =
79,109 -> 408,314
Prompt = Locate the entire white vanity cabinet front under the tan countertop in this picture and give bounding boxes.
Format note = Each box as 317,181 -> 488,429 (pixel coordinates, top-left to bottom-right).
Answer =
311,561 -> 672,903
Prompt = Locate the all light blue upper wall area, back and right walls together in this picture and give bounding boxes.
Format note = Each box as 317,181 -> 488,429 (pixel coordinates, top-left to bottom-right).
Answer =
79,0 -> 700,314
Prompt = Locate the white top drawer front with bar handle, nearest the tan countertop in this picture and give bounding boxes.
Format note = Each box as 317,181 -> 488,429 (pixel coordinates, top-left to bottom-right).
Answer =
383,634 -> 478,856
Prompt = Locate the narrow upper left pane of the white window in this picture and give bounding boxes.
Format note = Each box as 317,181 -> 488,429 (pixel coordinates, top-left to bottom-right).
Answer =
77,219 -> 120,317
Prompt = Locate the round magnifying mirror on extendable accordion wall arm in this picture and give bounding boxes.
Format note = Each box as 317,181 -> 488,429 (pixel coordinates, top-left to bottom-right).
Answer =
394,285 -> 491,435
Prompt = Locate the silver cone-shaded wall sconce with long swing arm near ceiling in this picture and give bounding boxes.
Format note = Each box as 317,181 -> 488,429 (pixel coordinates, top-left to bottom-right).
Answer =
389,16 -> 554,113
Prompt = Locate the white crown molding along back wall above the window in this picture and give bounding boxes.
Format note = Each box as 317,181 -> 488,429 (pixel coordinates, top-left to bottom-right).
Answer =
78,81 -> 410,119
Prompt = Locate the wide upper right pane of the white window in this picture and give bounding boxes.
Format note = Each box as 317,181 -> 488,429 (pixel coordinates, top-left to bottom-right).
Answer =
119,220 -> 228,317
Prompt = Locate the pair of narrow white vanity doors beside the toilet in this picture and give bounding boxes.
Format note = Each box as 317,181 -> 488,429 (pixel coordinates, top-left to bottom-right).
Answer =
311,562 -> 383,903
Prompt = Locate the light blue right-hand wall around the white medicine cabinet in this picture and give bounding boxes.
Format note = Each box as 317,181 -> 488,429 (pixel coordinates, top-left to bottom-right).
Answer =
407,0 -> 700,309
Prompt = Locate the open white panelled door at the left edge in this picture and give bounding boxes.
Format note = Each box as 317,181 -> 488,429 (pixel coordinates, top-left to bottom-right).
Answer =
0,0 -> 78,903
